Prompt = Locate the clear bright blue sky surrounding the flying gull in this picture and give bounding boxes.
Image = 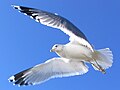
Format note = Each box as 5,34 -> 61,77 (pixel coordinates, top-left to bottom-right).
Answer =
0,0 -> 120,90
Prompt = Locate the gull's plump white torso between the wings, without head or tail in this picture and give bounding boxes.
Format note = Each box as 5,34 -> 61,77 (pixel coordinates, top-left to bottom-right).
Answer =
57,43 -> 93,61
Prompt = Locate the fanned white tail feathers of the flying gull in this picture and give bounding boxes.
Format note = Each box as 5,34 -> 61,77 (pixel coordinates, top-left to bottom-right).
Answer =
92,48 -> 113,70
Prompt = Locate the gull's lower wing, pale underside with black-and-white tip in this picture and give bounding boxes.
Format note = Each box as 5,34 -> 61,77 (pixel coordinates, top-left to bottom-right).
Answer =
9,58 -> 88,86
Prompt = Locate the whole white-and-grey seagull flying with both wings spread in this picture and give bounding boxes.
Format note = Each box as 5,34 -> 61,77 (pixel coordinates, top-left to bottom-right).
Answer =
9,5 -> 113,86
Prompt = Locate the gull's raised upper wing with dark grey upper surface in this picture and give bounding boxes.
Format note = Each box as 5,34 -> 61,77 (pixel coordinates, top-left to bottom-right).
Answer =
13,5 -> 93,51
